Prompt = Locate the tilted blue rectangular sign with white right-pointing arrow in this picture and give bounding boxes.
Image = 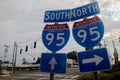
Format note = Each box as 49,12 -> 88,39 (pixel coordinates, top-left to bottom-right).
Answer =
78,48 -> 110,72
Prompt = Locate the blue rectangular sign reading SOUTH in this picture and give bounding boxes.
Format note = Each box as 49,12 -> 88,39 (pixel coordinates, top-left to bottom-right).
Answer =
44,9 -> 70,22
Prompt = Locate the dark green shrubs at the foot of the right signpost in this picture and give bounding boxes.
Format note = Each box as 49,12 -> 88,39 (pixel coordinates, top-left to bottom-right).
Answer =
77,63 -> 120,80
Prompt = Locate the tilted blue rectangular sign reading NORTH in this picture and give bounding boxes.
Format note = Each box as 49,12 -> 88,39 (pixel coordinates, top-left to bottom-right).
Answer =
71,1 -> 100,21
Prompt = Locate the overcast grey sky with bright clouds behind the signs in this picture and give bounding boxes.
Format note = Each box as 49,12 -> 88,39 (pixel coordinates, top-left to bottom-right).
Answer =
0,0 -> 120,63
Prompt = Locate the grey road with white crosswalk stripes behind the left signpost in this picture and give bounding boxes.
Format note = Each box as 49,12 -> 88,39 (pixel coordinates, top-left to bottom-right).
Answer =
0,68 -> 82,80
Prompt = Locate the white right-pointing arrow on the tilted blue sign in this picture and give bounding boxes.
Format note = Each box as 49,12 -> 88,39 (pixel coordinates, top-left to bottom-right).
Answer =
82,55 -> 103,66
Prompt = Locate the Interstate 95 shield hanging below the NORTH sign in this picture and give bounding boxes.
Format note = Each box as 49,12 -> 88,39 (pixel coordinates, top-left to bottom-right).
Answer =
72,16 -> 104,48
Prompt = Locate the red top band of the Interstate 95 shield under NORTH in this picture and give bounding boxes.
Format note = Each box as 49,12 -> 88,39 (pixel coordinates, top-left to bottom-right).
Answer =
73,16 -> 100,27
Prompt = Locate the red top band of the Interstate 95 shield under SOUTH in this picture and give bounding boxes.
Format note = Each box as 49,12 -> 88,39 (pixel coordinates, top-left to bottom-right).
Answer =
44,24 -> 69,30
